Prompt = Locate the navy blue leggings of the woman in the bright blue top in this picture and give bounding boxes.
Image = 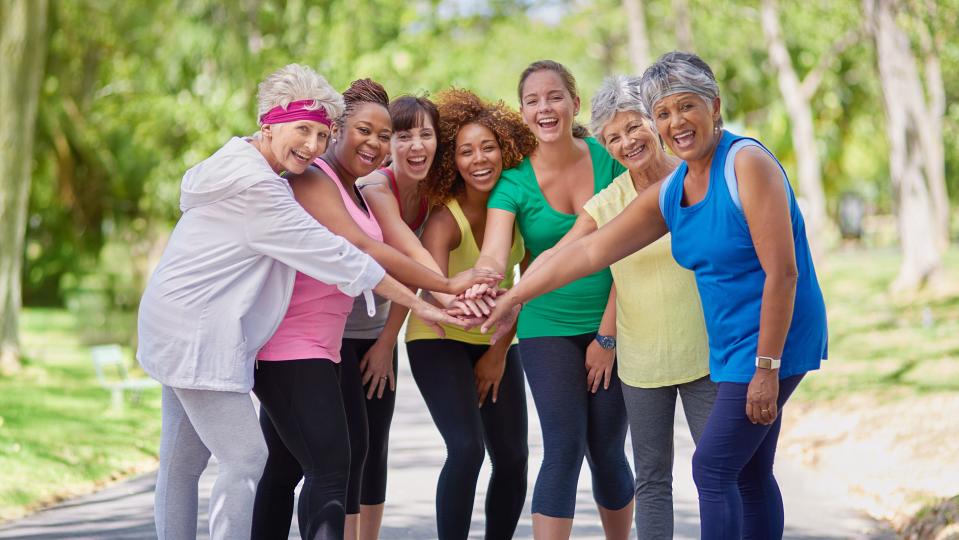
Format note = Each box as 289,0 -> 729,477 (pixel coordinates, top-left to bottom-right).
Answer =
693,375 -> 803,540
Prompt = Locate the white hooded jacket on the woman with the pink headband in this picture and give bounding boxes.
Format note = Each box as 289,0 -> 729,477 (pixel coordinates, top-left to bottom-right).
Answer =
137,138 -> 385,392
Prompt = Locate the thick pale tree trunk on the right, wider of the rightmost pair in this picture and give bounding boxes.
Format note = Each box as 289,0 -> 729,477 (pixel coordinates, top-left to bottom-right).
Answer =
863,0 -> 948,291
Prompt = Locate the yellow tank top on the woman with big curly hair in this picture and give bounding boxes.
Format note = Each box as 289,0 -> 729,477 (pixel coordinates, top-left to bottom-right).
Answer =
406,199 -> 526,345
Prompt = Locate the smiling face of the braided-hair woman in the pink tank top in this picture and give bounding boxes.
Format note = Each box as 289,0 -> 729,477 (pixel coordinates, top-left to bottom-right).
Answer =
334,103 -> 393,178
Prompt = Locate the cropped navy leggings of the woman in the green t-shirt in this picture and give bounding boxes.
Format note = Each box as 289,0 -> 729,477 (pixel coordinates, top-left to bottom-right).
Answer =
519,333 -> 633,518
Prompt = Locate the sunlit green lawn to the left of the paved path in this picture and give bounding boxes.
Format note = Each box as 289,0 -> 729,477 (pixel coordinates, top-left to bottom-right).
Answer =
0,309 -> 160,519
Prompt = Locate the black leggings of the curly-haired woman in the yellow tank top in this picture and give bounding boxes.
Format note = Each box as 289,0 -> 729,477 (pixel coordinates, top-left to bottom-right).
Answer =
406,339 -> 532,540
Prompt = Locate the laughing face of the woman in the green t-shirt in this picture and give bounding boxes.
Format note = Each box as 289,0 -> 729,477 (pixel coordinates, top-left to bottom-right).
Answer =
520,69 -> 579,143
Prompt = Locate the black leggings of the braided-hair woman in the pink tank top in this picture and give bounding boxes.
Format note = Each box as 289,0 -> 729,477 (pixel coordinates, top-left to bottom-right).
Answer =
252,359 -> 350,540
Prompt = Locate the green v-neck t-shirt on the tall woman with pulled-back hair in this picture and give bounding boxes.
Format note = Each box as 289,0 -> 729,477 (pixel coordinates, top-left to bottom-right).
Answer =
488,137 -> 626,339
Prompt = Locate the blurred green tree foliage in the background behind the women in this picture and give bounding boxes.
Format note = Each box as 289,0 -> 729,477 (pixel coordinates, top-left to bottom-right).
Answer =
23,0 -> 959,333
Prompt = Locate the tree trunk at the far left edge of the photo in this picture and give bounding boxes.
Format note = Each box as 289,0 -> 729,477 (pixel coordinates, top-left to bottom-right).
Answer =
0,0 -> 47,373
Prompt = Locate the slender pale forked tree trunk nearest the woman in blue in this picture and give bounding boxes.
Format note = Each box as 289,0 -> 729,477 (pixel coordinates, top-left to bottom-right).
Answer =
762,0 -> 831,258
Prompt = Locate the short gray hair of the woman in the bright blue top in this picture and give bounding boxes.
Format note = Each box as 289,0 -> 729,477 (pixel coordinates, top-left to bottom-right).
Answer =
641,51 -> 723,126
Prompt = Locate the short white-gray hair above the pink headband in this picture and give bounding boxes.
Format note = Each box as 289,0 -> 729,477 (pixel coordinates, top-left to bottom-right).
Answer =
256,64 -> 344,124
